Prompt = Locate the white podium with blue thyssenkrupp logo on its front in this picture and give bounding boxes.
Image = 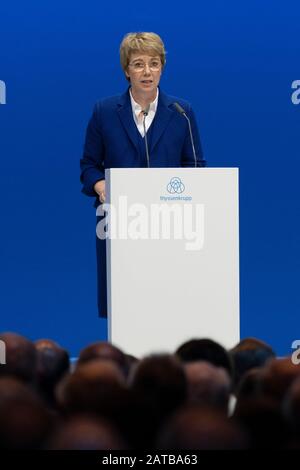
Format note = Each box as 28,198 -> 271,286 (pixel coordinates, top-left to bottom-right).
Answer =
105,168 -> 239,357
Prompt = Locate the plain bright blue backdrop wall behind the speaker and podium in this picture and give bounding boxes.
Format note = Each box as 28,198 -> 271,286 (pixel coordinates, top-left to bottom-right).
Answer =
0,0 -> 300,355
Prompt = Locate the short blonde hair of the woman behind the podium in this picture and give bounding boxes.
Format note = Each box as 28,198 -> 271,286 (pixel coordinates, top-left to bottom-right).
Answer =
120,33 -> 166,72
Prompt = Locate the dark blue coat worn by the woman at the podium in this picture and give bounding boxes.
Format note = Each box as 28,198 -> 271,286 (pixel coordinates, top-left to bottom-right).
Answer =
80,89 -> 205,316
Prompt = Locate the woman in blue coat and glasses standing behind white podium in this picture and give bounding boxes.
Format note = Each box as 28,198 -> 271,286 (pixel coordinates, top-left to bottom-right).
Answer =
80,32 -> 205,317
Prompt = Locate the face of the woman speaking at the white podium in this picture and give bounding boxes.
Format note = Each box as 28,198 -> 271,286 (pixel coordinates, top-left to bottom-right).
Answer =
125,53 -> 162,94
